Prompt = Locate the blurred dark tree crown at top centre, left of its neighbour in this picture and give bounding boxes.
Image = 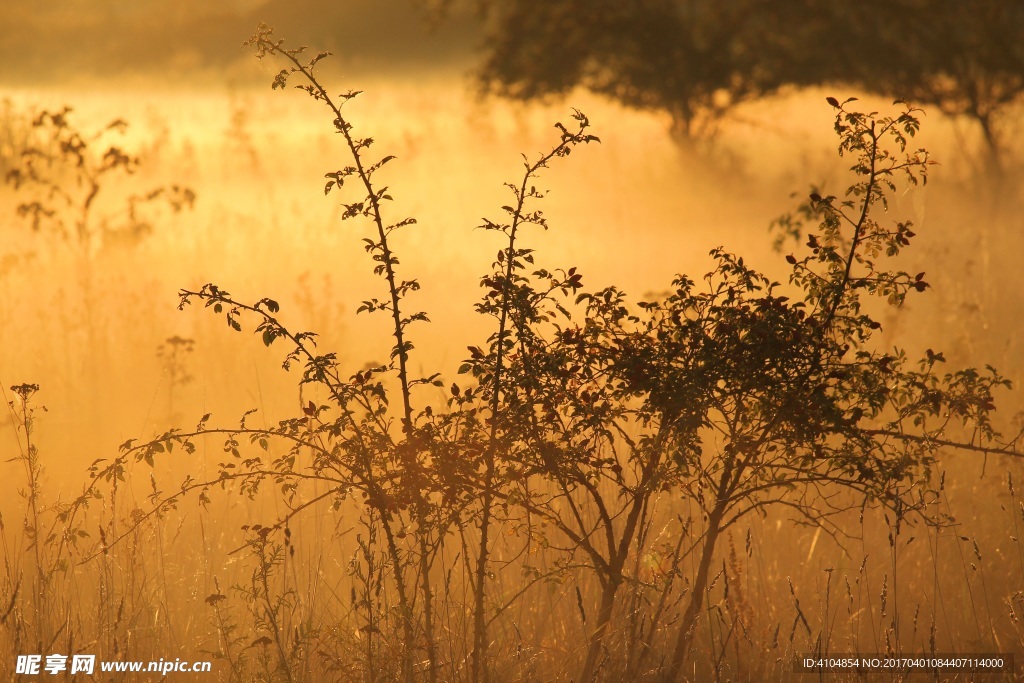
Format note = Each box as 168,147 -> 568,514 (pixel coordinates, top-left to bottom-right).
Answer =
464,0 -> 815,138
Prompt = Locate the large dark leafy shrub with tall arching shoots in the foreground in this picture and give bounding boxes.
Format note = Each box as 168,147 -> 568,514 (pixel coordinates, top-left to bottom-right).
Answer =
70,26 -> 1021,682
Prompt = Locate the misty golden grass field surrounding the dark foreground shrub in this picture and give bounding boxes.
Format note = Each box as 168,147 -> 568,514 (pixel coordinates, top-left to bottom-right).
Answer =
0,56 -> 1024,682
